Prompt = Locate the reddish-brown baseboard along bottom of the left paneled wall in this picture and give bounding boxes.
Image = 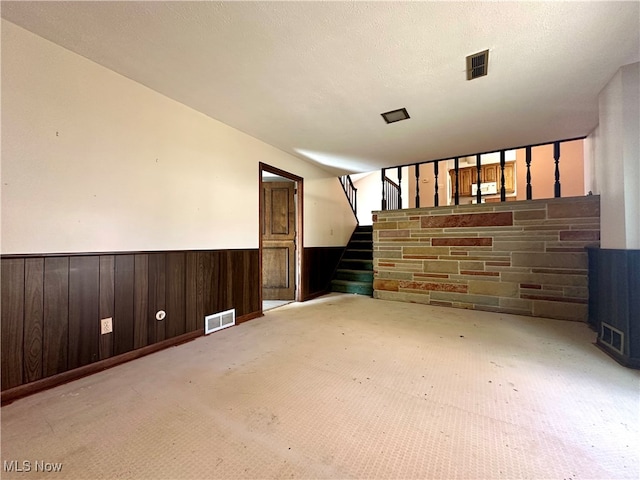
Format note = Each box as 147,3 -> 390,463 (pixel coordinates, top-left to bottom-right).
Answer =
0,311 -> 263,406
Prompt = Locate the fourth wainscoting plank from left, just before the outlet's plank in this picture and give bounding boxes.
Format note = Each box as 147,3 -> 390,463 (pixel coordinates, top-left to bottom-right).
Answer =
69,256 -> 100,368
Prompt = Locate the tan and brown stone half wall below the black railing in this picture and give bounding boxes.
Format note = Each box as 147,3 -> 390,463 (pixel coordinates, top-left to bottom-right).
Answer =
373,195 -> 600,321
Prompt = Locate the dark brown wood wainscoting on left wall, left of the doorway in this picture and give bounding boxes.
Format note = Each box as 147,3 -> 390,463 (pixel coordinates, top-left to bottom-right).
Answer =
0,249 -> 262,399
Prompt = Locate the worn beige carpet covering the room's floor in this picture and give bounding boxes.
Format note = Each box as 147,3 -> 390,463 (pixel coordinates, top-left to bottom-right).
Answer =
1,294 -> 640,479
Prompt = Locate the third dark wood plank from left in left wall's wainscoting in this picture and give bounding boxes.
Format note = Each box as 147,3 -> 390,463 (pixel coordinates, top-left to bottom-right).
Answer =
42,257 -> 69,377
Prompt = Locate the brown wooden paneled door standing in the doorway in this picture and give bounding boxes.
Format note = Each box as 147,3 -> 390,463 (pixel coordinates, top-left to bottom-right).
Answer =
262,182 -> 296,300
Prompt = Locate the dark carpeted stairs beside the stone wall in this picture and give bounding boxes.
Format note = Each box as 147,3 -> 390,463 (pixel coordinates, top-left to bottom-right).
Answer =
331,225 -> 373,296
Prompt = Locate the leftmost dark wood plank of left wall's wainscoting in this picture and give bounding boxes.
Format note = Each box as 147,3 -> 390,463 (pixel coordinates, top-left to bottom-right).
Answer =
0,258 -> 24,389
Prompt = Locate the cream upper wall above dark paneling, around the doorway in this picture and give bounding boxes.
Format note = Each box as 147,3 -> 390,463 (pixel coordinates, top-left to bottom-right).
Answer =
0,20 -> 355,254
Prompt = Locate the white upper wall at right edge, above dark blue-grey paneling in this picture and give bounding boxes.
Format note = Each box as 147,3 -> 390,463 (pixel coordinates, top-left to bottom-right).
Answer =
589,63 -> 640,249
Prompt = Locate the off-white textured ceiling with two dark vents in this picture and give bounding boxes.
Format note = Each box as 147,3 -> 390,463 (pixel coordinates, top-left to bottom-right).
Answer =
2,1 -> 640,173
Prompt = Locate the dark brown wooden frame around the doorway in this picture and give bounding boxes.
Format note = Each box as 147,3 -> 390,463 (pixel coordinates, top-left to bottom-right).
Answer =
258,162 -> 304,306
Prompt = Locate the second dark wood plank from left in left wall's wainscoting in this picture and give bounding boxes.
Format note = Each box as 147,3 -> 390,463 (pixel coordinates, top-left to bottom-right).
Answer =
23,258 -> 44,382
